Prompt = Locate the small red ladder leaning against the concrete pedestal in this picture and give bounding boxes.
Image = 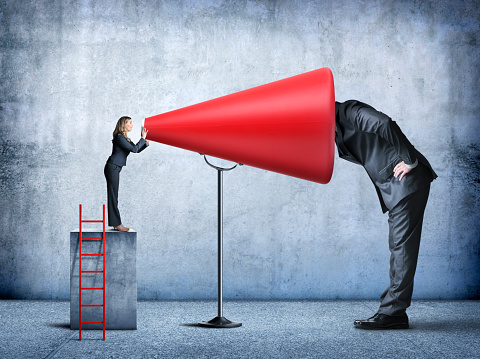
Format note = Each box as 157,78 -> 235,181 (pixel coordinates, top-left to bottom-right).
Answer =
78,205 -> 105,340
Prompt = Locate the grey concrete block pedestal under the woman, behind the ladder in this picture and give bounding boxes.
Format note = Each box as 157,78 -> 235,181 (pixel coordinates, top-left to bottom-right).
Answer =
70,229 -> 137,329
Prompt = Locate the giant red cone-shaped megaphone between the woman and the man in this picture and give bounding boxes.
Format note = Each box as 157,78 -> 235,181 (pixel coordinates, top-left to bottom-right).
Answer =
143,68 -> 335,183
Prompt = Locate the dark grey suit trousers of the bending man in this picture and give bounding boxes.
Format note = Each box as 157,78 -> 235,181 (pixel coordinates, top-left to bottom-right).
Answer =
378,185 -> 430,316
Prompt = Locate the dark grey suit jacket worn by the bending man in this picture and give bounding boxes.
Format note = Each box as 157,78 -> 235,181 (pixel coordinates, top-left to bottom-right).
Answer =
335,100 -> 437,213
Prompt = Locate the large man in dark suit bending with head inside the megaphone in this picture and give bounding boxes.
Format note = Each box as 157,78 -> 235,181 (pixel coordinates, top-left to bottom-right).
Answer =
335,100 -> 437,329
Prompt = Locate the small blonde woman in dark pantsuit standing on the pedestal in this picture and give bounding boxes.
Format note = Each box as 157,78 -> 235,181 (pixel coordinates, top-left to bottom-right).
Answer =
104,116 -> 150,232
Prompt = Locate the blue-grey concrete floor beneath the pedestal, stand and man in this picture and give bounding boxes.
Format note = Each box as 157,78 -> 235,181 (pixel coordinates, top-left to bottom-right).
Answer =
0,300 -> 480,359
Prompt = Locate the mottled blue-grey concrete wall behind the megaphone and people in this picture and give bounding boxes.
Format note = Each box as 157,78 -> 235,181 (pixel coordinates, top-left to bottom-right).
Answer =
0,0 -> 480,299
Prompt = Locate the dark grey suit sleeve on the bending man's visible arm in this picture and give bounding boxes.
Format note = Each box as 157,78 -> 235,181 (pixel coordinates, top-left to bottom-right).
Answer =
354,107 -> 418,167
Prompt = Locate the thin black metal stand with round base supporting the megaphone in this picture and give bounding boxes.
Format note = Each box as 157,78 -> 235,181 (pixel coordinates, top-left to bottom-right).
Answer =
198,155 -> 242,328
